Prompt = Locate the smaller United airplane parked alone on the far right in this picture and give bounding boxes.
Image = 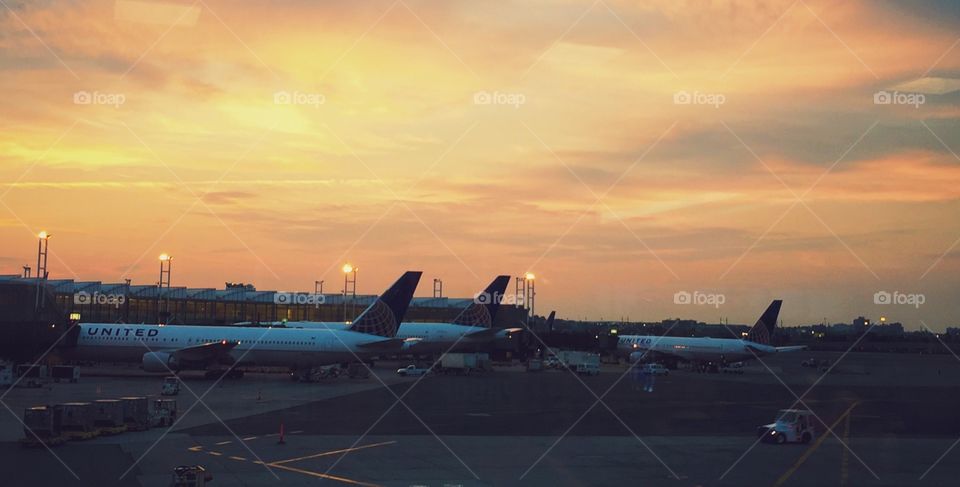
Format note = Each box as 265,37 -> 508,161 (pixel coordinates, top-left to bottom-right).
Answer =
617,299 -> 807,365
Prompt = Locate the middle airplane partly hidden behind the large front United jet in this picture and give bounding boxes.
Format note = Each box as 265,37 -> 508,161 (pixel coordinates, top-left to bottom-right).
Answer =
276,276 -> 522,355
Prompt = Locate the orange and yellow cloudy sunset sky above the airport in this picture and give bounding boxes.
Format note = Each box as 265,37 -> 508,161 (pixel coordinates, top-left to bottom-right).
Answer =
0,0 -> 960,331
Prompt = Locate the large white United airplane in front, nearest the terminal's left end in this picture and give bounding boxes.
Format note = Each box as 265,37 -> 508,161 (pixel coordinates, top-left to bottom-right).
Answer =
63,271 -> 422,377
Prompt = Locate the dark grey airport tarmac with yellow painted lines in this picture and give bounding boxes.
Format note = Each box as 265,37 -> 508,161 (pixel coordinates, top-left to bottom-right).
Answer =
0,352 -> 960,486
